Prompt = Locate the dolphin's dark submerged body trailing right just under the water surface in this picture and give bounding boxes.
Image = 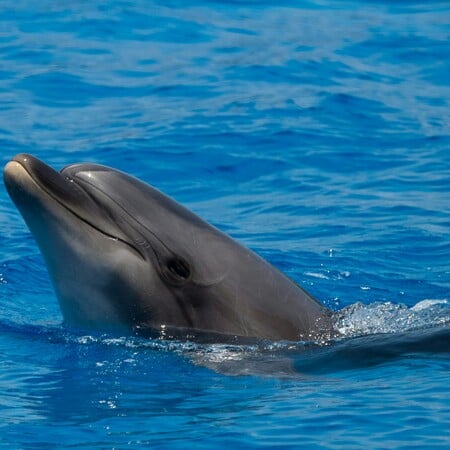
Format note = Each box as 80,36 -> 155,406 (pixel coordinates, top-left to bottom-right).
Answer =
187,326 -> 450,377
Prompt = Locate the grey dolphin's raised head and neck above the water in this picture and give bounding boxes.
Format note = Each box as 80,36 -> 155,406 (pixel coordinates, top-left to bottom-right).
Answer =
4,154 -> 333,340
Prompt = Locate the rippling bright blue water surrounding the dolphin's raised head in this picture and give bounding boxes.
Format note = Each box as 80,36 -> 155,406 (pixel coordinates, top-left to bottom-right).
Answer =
0,0 -> 450,449
